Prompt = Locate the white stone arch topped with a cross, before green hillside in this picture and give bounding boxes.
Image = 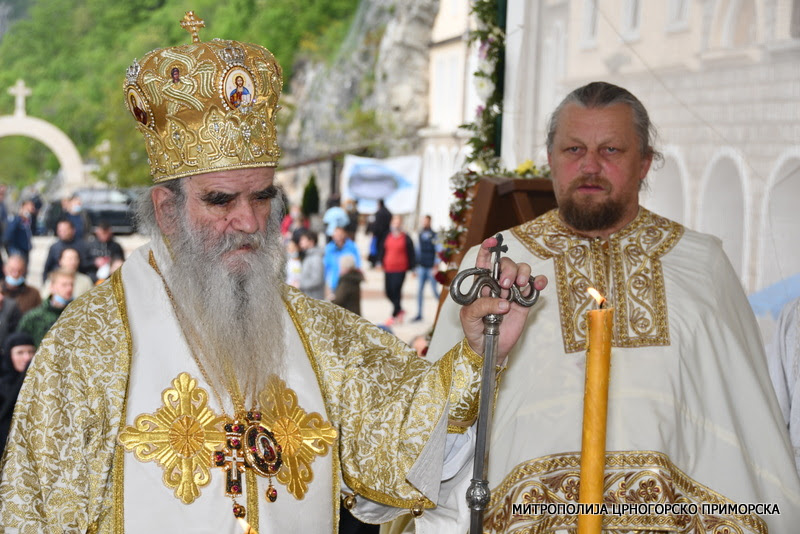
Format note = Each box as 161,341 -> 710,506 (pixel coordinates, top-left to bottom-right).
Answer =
0,80 -> 86,191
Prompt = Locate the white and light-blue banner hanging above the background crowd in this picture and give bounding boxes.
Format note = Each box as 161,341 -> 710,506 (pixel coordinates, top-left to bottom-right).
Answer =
340,155 -> 422,215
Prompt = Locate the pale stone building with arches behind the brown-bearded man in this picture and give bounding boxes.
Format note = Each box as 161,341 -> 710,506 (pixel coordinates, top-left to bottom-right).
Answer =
502,0 -> 800,298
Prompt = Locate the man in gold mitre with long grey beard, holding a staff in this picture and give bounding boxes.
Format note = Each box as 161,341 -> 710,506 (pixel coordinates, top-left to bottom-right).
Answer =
0,12 -> 544,533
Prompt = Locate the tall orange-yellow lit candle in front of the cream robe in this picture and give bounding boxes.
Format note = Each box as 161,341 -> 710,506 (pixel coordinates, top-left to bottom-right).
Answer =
578,287 -> 614,534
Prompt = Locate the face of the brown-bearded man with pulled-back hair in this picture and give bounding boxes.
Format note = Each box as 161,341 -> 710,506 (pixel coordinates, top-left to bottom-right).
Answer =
547,103 -> 652,238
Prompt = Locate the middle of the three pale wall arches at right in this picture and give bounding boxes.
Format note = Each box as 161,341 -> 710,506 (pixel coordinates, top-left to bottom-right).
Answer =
695,147 -> 752,287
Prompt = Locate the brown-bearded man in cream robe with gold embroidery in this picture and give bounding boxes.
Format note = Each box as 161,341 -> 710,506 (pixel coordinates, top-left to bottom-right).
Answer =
430,82 -> 800,533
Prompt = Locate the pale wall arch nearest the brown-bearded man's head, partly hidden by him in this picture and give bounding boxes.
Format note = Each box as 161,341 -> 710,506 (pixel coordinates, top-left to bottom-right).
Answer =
640,145 -> 690,226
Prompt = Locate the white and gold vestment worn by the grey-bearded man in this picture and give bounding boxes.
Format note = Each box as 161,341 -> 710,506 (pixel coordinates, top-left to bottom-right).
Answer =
0,246 -> 480,533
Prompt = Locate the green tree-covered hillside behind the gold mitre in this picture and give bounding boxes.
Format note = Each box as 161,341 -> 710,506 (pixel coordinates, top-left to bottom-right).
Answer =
0,0 -> 359,191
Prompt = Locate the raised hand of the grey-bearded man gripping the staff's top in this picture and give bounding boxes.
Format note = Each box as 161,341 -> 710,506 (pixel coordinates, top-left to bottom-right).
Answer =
460,237 -> 547,365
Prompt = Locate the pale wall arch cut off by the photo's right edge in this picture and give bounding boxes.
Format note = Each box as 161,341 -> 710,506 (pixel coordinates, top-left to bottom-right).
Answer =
756,146 -> 800,289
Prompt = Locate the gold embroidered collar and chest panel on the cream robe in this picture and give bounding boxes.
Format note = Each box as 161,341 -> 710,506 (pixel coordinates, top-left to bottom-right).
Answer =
511,207 -> 684,353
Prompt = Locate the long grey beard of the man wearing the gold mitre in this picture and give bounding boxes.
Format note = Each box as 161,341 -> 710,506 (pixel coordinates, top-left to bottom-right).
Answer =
154,210 -> 286,409
